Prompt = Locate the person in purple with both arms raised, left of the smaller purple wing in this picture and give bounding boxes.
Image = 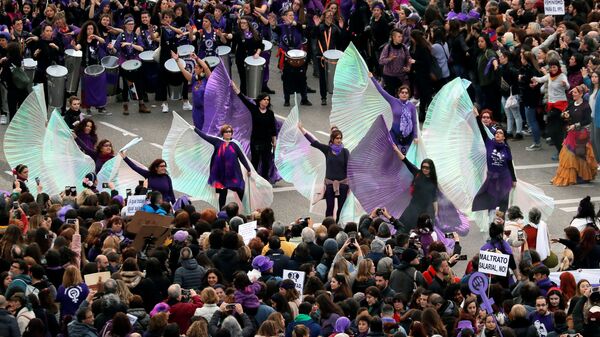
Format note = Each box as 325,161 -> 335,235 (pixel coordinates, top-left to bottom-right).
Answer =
171,53 -> 211,130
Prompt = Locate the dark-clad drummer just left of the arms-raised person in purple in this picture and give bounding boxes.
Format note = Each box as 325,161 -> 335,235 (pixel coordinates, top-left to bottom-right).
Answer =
156,8 -> 183,113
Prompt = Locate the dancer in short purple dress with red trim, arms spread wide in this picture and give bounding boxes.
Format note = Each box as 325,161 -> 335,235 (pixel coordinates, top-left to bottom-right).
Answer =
194,124 -> 251,209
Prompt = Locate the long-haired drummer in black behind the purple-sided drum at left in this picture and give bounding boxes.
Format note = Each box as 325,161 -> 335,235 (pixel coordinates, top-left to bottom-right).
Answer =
75,20 -> 106,116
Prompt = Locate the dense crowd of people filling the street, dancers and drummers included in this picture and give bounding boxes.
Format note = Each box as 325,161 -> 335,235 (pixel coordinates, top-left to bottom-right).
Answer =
0,0 -> 600,337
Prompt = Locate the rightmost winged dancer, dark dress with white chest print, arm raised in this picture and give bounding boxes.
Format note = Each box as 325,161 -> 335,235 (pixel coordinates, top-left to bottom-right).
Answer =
472,106 -> 517,219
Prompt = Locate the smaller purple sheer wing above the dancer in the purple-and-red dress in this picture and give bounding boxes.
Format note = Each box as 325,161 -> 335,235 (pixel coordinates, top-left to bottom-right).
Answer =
202,63 -> 252,155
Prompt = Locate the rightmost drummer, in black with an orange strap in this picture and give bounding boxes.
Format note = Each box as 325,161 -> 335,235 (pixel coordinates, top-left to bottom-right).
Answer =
313,10 -> 344,105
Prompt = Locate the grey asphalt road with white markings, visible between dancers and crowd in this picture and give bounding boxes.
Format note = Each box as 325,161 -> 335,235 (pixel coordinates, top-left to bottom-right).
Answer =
0,58 -> 600,274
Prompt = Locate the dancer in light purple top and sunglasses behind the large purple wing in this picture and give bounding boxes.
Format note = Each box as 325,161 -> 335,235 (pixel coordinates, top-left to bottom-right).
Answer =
369,73 -> 417,154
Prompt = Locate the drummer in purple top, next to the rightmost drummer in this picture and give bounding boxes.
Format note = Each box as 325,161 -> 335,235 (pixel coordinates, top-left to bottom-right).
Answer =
271,9 -> 312,106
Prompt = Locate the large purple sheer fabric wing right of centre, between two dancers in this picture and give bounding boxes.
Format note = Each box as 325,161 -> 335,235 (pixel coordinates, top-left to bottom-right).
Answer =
348,115 -> 413,217
